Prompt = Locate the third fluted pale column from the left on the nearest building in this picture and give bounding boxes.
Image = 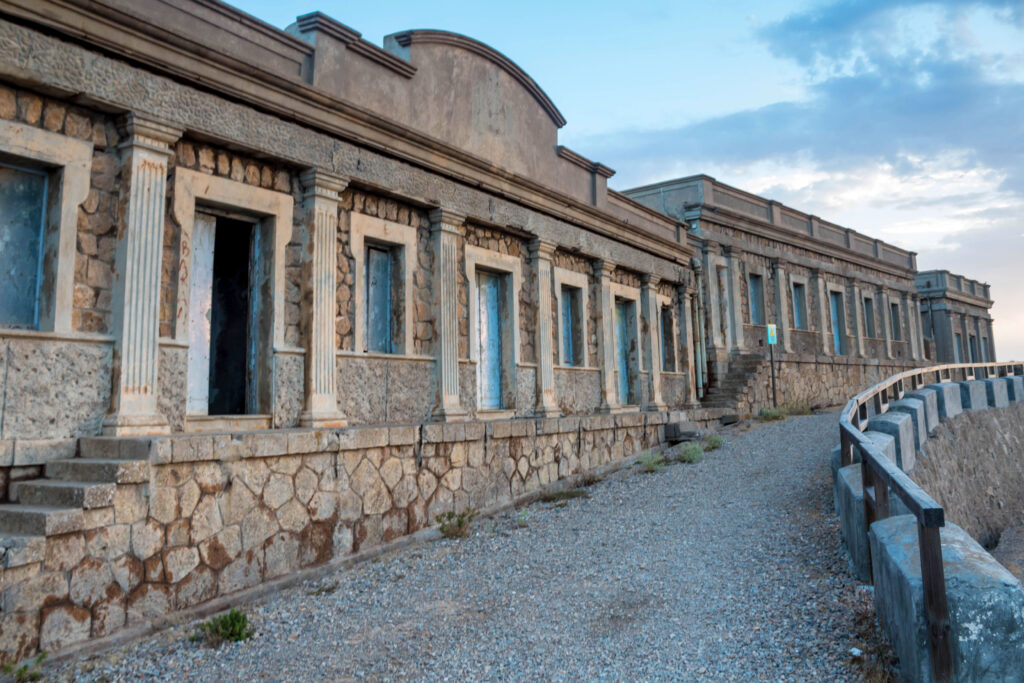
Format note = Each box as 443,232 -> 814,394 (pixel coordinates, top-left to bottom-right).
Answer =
429,209 -> 466,422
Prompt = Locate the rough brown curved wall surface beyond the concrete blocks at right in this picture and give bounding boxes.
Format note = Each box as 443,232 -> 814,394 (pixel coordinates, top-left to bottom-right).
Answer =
912,402 -> 1024,548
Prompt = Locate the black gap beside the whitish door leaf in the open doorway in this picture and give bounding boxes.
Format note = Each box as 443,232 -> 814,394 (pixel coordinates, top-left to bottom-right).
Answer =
209,218 -> 254,415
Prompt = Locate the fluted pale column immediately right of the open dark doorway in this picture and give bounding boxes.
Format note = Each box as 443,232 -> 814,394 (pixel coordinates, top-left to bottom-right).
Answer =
300,169 -> 350,428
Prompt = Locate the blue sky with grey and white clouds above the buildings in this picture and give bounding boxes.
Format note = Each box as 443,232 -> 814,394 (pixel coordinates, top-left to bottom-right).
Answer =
233,0 -> 1024,359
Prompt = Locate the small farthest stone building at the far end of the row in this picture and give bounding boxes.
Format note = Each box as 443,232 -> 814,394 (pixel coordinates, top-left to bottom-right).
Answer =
914,270 -> 995,362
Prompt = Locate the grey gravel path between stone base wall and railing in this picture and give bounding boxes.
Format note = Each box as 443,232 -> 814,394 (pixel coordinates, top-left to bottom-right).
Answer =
47,415 -> 864,681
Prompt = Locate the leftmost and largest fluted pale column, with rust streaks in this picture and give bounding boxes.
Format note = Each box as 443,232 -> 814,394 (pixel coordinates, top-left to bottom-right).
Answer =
103,114 -> 181,436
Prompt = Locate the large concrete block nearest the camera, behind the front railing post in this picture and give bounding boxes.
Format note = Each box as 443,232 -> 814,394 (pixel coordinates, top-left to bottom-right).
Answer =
869,515 -> 1024,681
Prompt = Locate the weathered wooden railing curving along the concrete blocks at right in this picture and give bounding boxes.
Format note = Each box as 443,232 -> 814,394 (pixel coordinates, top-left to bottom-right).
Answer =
839,361 -> 1024,682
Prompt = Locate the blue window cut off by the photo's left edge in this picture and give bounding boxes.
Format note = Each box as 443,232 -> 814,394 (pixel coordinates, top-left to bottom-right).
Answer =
0,164 -> 48,328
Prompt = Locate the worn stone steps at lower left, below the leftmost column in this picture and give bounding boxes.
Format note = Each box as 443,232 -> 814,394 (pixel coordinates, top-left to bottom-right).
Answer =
0,437 -> 150,567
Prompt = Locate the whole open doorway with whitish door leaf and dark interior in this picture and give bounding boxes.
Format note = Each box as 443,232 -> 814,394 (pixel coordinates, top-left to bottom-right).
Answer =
187,213 -> 262,416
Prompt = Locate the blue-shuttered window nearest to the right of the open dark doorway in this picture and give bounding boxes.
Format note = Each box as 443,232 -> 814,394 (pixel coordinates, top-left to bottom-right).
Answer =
365,244 -> 402,353
